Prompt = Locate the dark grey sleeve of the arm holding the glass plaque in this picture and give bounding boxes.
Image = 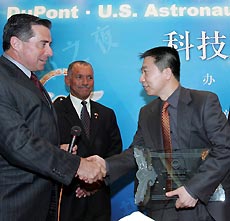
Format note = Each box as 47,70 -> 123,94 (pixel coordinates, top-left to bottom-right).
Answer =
186,93 -> 230,203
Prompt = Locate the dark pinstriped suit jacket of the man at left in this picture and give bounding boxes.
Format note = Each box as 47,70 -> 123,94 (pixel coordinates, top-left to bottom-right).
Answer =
0,57 -> 80,221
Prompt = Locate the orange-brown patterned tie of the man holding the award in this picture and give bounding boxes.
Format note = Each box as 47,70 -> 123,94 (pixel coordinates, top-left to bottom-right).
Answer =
161,101 -> 172,191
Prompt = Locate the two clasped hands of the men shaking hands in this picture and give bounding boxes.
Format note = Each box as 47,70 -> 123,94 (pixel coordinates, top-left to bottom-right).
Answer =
75,155 -> 106,183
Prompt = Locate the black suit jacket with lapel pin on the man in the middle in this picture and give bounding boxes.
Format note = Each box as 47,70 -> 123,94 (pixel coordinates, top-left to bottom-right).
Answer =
55,96 -> 122,221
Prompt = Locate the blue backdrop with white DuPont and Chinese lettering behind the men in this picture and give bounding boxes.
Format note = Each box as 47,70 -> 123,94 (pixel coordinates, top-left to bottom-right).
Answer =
0,0 -> 230,221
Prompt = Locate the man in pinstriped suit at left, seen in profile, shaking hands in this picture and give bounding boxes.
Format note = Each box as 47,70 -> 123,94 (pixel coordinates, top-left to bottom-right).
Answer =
0,14 -> 103,221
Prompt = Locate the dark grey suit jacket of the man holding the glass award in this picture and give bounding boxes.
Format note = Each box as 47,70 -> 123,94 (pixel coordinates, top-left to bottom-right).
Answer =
107,87 -> 230,221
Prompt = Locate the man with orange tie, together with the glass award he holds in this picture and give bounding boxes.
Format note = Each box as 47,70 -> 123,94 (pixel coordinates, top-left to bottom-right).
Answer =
87,47 -> 230,221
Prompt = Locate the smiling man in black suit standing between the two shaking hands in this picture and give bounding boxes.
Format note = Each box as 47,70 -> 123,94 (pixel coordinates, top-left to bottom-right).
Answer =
55,61 -> 122,221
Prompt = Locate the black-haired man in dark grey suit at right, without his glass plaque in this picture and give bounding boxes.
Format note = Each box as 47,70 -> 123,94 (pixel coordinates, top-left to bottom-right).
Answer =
89,47 -> 230,221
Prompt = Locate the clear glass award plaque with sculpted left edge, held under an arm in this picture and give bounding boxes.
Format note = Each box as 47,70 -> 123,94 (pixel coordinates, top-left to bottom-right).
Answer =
134,146 -> 225,205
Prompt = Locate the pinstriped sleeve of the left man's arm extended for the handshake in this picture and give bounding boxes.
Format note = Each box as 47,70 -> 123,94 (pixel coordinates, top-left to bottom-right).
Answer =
0,75 -> 80,184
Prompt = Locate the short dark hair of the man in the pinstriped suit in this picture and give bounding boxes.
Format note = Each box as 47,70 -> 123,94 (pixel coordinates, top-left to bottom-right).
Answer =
2,14 -> 51,51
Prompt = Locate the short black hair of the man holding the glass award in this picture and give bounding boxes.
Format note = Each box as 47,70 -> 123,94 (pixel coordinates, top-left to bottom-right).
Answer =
140,46 -> 180,81
